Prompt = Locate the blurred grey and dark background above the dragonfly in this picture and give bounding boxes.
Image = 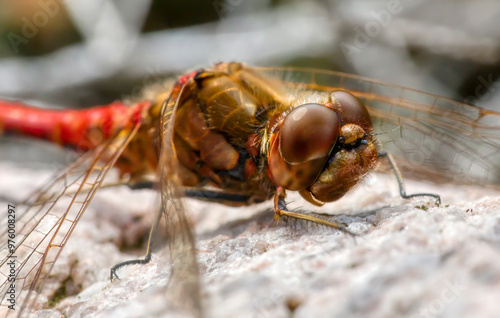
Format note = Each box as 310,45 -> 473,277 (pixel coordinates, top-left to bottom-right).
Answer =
0,0 -> 500,164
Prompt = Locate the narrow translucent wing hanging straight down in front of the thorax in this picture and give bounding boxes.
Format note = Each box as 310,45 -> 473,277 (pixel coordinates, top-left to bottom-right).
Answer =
159,82 -> 202,317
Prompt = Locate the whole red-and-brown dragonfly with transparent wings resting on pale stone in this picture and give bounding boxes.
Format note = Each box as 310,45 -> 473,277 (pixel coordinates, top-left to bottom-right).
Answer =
0,62 -> 500,316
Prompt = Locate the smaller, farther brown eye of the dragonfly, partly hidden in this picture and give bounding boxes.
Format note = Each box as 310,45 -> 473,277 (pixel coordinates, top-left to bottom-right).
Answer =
331,91 -> 372,134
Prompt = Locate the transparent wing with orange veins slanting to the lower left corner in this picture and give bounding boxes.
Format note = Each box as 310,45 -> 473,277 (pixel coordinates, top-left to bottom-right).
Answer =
0,123 -> 140,316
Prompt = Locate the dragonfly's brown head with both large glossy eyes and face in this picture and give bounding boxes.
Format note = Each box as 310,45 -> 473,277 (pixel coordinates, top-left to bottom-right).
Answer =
268,91 -> 377,205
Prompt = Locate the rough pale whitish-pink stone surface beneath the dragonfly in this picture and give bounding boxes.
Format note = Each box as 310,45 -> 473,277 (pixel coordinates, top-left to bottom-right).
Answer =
0,163 -> 500,318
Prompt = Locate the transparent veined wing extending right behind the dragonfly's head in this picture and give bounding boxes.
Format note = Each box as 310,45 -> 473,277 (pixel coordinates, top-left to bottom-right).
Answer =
260,68 -> 500,184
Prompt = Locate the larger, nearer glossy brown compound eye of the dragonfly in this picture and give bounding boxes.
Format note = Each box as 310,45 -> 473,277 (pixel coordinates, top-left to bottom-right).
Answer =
279,104 -> 340,164
